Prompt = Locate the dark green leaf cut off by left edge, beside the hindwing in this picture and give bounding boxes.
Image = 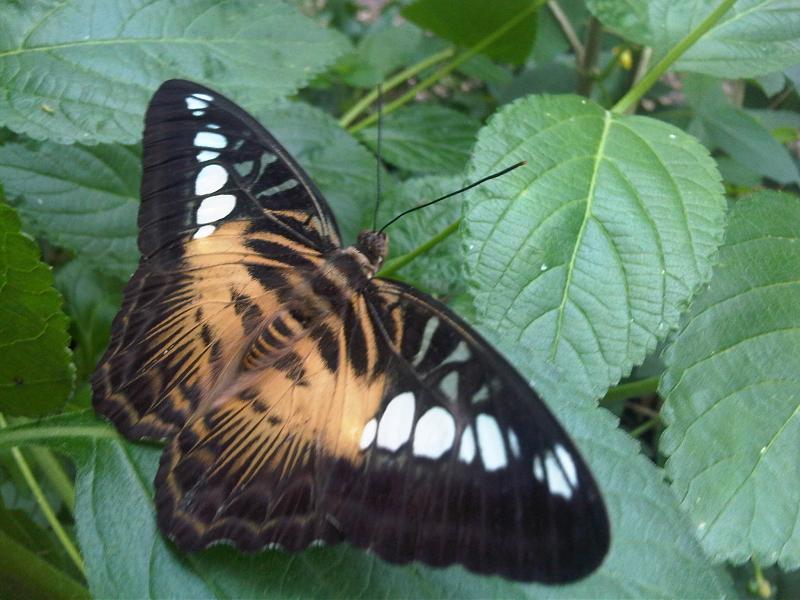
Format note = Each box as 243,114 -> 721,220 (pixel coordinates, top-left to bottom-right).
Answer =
0,195 -> 75,416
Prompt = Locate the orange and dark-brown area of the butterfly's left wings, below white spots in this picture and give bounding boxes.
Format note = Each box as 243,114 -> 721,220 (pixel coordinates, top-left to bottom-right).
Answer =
92,221 -> 321,439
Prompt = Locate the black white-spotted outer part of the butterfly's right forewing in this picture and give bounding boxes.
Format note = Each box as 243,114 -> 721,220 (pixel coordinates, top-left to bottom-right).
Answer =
320,279 -> 610,583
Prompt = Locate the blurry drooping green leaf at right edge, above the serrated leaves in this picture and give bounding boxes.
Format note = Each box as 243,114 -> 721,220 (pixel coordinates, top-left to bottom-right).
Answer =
684,76 -> 800,184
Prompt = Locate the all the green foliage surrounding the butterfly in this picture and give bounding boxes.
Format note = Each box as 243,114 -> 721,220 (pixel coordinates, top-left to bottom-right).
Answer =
0,0 -> 800,598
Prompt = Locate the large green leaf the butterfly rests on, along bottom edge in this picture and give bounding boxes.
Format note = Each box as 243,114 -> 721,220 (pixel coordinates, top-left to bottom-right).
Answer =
0,378 -> 730,598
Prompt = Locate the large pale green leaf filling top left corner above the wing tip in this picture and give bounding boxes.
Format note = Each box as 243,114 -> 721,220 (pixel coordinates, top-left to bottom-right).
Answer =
0,0 -> 347,143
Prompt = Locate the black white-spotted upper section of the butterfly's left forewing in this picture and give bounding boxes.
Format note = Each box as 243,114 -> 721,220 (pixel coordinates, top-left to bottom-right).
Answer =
139,79 -> 340,258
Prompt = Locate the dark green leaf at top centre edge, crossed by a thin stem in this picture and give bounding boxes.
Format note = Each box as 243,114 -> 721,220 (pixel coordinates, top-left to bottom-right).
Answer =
402,0 -> 536,64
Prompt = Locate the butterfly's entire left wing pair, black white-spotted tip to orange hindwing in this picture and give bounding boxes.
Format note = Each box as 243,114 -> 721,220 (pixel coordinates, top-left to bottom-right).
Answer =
93,81 -> 339,439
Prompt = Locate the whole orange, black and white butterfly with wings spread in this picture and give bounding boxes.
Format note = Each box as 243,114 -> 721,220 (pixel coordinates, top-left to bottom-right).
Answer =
92,80 -> 610,582
